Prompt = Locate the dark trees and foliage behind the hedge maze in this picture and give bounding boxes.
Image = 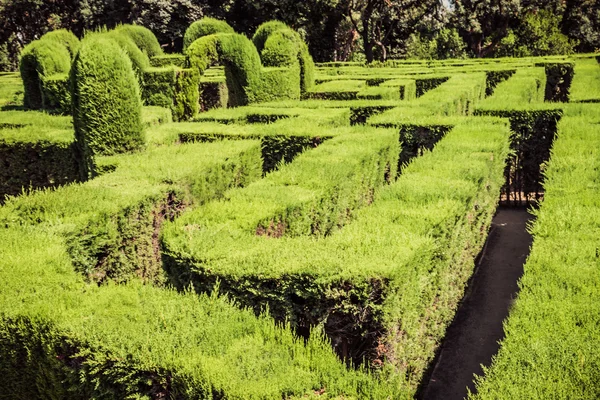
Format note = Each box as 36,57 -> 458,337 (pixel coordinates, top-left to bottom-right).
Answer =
0,0 -> 600,70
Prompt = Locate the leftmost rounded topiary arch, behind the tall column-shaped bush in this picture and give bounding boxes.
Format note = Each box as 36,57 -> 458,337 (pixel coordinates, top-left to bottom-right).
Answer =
19,40 -> 71,109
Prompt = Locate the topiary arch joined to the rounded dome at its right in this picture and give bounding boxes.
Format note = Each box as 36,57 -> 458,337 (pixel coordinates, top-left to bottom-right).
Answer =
186,18 -> 314,106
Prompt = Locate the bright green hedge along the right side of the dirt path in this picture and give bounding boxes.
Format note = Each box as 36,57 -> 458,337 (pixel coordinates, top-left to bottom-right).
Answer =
470,108 -> 600,399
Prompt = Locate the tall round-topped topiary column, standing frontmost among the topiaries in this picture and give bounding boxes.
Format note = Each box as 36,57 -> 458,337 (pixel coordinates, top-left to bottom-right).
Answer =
71,34 -> 144,180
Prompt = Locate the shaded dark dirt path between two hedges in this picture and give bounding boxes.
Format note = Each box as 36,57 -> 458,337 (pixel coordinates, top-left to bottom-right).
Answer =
419,208 -> 532,400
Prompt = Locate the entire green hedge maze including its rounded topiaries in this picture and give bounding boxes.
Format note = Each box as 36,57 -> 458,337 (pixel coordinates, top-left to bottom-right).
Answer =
0,18 -> 600,399
